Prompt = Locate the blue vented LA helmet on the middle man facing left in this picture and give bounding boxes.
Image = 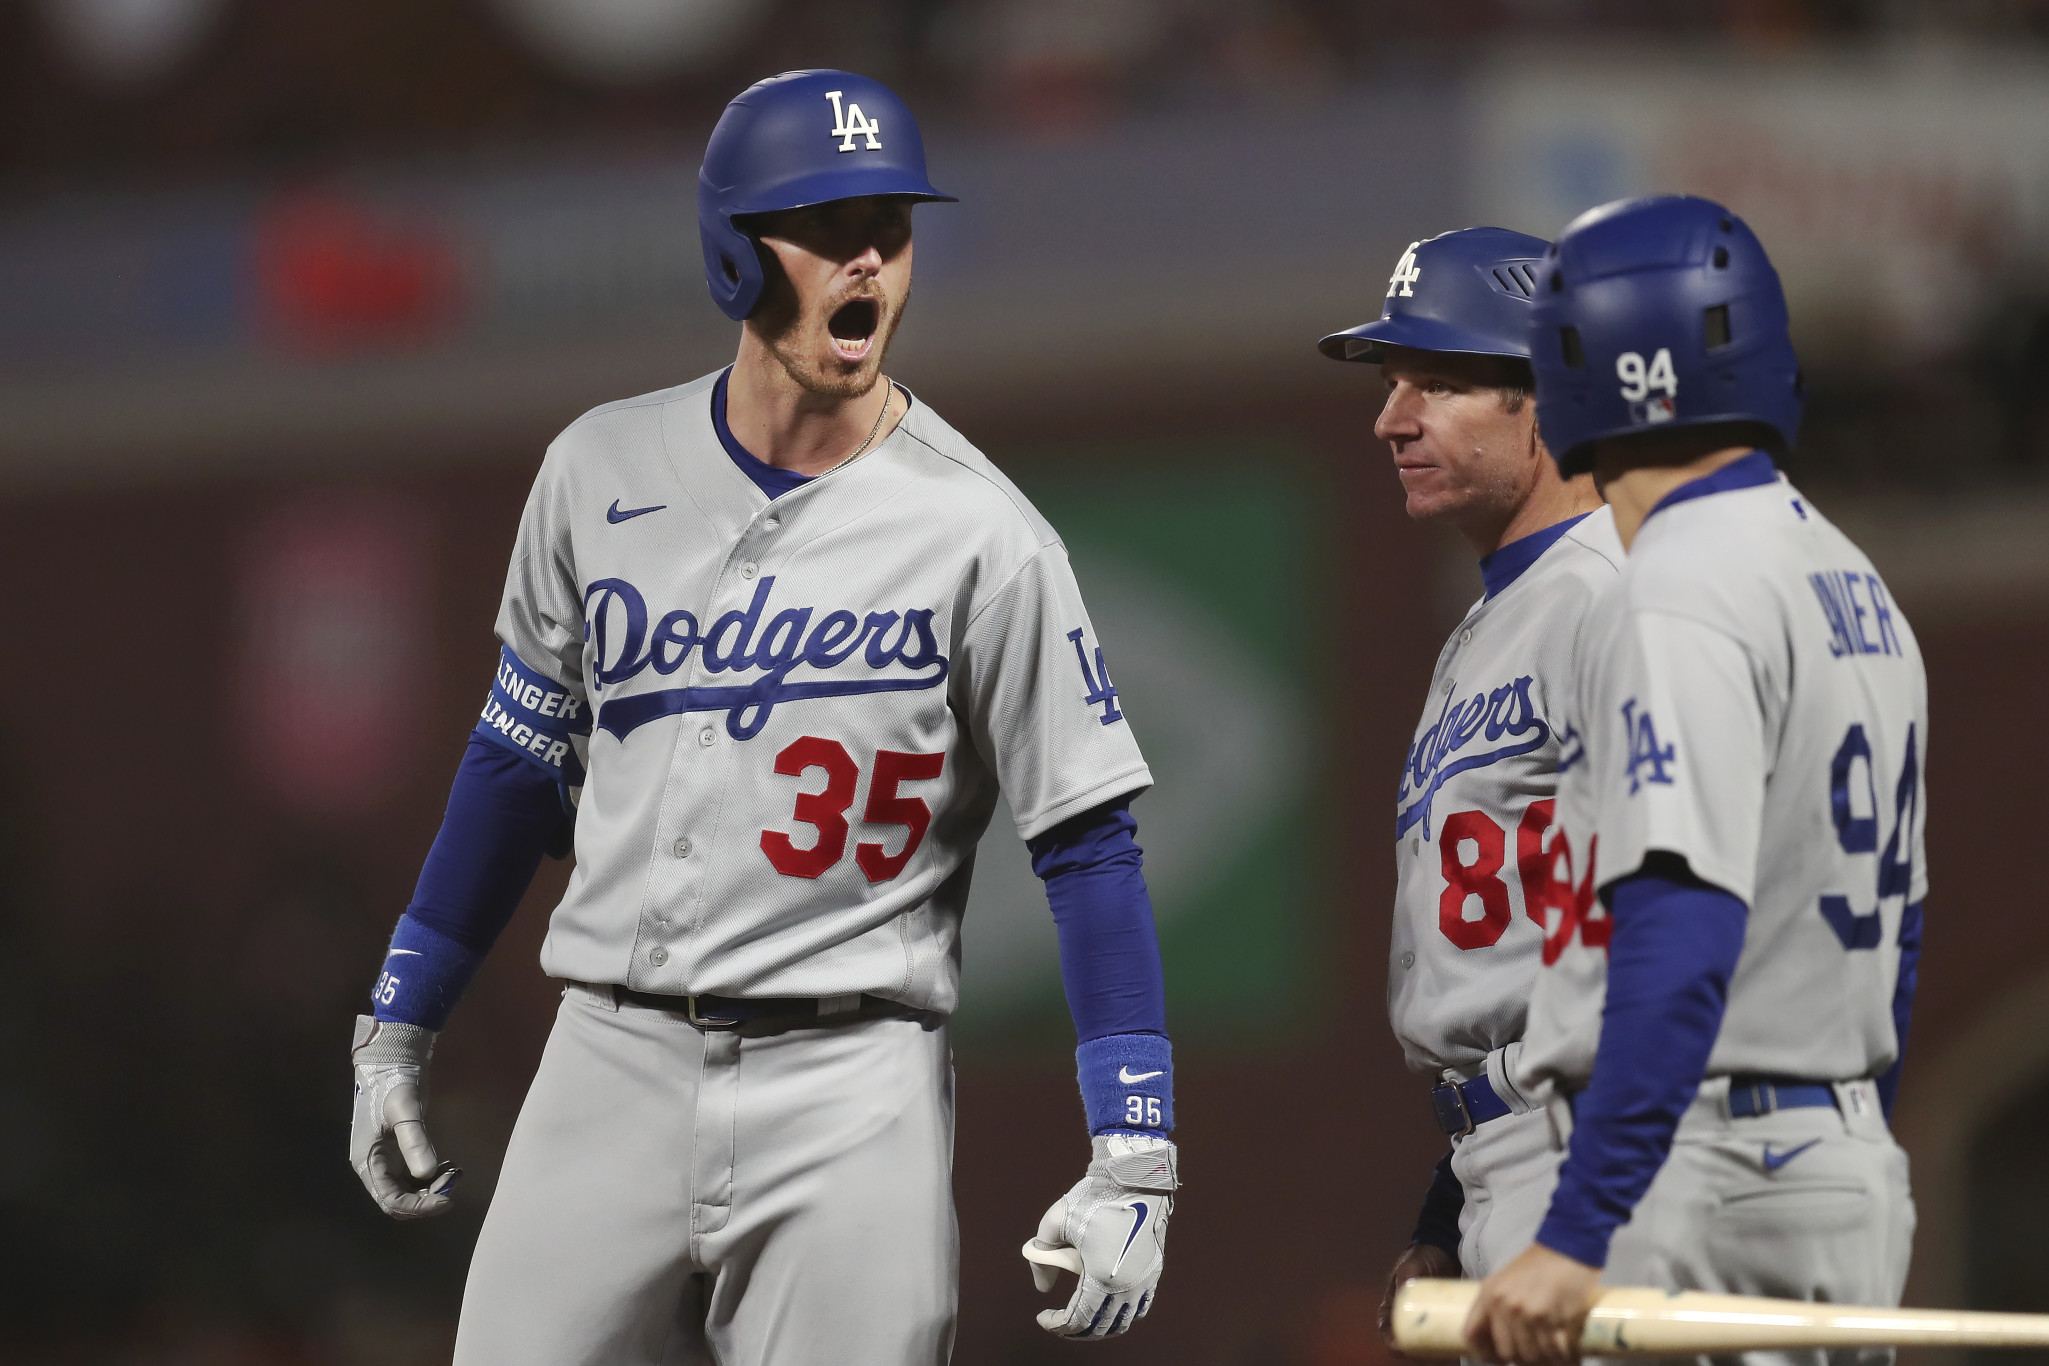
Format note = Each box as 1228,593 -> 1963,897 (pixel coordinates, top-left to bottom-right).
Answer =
1315,227 -> 1551,360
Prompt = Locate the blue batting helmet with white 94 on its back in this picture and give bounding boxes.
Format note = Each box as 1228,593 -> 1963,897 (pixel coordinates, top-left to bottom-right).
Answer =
1531,195 -> 1801,475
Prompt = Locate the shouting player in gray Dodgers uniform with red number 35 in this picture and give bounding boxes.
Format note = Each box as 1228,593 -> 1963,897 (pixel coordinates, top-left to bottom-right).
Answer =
350,72 -> 1176,1366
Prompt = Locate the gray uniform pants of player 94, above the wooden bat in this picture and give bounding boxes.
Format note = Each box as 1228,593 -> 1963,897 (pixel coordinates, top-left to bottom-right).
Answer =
1551,1077 -> 1914,1366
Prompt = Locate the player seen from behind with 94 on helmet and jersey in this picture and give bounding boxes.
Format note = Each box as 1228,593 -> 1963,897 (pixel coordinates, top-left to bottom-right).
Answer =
1467,197 -> 1928,1366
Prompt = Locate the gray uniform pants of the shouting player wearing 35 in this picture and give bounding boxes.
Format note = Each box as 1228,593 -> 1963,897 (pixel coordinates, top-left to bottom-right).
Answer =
455,985 -> 959,1366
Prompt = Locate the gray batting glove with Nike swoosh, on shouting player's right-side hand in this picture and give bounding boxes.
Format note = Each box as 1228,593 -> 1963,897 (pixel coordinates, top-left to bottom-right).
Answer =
1025,1135 -> 1180,1337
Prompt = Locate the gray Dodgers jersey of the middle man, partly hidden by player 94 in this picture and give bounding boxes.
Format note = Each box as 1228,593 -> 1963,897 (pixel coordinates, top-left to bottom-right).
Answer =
1387,508 -> 1623,1075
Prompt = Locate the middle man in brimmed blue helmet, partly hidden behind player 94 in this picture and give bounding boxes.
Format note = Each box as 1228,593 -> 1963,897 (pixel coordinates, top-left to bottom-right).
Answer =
1322,227 -> 1623,1333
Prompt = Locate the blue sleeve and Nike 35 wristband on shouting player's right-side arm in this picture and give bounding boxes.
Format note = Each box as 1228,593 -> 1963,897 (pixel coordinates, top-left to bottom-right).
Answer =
1029,797 -> 1174,1135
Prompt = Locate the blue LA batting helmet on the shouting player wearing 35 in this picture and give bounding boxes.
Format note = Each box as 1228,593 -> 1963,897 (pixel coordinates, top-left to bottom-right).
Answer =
697,72 -> 953,322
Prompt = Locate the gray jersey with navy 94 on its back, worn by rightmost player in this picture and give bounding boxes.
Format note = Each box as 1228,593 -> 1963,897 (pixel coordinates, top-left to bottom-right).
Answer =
1522,464 -> 1928,1090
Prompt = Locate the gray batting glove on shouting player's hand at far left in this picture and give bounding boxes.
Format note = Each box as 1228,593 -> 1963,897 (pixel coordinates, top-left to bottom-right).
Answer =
348,1016 -> 463,1219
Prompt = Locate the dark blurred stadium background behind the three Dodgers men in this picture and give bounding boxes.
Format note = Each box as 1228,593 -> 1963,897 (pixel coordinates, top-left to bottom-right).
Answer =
0,0 -> 2049,1366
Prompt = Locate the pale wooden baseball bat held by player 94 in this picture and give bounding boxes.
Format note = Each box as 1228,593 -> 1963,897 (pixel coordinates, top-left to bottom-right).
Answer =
1393,1280 -> 2049,1358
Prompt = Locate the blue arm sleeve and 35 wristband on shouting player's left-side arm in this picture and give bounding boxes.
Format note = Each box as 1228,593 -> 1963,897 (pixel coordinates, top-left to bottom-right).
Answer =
371,735 -> 568,1030
